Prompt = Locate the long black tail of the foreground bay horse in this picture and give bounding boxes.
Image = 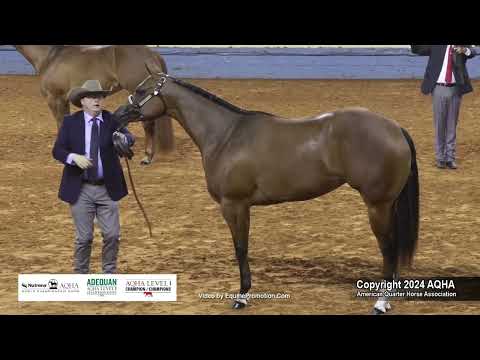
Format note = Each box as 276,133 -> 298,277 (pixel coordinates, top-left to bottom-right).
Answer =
393,129 -> 420,266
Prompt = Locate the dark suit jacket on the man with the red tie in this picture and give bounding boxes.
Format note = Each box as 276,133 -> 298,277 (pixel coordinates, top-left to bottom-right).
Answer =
411,45 -> 476,95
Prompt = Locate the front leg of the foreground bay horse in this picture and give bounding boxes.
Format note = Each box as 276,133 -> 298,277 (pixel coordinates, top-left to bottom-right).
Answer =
221,199 -> 252,309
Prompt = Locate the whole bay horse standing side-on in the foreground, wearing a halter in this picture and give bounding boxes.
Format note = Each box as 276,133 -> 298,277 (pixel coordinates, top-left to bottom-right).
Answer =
114,73 -> 419,314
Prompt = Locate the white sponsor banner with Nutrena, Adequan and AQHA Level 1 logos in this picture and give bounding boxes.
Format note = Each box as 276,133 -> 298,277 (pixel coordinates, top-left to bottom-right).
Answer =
18,274 -> 177,301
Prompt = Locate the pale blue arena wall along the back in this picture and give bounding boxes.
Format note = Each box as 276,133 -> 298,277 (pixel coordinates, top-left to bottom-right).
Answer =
0,45 -> 480,79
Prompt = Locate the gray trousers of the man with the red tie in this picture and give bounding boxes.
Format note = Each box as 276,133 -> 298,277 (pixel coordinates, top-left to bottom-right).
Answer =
433,85 -> 462,161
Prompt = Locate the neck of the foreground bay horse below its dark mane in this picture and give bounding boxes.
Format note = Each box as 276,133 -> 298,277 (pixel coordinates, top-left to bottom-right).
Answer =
166,83 -> 239,155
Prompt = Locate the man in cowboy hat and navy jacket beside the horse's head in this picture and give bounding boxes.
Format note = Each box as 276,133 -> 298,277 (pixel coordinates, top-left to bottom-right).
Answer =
52,80 -> 135,274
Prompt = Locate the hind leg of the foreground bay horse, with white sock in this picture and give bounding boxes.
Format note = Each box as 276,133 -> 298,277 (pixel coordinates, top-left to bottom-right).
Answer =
367,201 -> 398,314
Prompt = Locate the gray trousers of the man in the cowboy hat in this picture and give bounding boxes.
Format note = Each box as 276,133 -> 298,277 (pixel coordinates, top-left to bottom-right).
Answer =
70,184 -> 120,274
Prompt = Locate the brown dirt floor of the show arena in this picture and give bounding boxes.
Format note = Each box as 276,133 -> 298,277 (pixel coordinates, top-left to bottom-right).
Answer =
0,76 -> 480,314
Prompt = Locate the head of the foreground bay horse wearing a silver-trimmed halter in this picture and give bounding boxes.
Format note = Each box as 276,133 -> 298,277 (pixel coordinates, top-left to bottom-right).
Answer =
114,65 -> 169,127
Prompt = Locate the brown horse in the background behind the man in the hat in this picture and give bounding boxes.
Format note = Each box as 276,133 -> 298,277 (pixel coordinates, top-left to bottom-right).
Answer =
14,45 -> 174,165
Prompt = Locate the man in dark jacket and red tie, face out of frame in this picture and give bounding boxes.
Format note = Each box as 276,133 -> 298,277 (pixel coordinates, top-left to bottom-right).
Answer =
411,45 -> 476,170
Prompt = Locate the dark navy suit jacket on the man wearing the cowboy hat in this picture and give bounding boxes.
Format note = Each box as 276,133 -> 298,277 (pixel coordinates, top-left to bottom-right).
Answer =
52,111 -> 135,204
